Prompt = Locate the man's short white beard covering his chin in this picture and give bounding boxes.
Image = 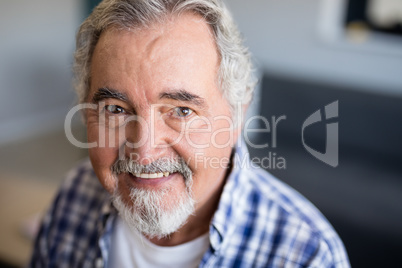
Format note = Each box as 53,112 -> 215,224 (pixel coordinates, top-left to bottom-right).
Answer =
113,184 -> 195,239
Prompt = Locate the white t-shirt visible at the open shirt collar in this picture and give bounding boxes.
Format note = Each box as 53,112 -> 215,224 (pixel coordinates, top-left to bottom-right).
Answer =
107,217 -> 209,268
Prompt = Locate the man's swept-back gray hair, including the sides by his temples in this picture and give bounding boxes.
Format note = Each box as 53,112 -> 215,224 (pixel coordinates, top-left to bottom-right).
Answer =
74,0 -> 255,122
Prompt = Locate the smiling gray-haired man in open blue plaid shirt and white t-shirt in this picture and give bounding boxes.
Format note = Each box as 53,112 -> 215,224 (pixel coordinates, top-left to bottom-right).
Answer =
31,0 -> 349,267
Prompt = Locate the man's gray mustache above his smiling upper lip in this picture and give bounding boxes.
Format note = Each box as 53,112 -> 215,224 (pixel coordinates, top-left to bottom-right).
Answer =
111,157 -> 192,179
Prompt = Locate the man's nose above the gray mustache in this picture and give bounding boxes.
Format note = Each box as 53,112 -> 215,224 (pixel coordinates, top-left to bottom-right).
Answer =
125,112 -> 168,165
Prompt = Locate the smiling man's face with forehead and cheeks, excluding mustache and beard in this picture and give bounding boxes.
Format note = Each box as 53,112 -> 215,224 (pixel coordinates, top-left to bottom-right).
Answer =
86,14 -> 237,234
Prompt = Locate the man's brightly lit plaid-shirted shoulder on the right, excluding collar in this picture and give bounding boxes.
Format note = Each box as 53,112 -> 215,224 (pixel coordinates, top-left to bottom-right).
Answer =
218,165 -> 349,267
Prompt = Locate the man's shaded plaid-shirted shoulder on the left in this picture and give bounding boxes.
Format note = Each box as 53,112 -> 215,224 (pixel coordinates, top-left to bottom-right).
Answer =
31,159 -> 109,267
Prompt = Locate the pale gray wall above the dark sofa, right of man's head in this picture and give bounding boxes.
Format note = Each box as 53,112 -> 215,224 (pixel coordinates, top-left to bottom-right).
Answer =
225,0 -> 402,96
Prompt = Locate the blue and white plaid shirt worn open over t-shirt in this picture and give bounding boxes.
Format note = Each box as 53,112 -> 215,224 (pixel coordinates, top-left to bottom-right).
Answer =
30,141 -> 350,268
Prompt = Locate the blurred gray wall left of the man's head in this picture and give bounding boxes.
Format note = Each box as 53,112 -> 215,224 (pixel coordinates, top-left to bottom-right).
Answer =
0,0 -> 82,143
